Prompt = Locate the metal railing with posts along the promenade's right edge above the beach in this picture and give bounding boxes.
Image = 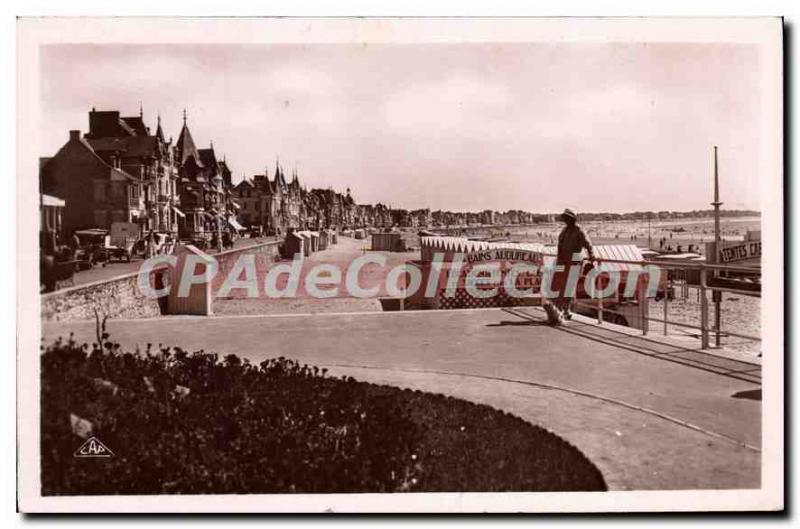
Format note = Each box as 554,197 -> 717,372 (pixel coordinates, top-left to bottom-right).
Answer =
575,259 -> 761,349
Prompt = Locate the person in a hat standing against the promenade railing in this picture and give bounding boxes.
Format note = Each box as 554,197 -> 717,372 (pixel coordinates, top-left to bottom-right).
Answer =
544,208 -> 594,325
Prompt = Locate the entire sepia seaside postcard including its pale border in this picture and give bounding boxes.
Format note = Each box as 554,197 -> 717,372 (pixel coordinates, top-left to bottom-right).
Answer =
17,18 -> 784,512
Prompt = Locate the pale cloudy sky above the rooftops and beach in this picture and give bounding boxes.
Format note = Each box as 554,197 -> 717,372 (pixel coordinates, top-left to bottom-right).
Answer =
40,43 -> 764,212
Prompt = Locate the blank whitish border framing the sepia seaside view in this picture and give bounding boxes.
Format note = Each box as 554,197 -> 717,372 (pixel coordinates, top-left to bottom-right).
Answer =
17,18 -> 784,512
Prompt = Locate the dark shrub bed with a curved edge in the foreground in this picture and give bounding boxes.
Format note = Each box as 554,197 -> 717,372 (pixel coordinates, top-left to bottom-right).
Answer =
41,336 -> 605,495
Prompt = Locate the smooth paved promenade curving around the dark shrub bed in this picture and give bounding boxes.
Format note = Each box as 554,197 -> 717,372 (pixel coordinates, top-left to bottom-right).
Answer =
42,309 -> 761,490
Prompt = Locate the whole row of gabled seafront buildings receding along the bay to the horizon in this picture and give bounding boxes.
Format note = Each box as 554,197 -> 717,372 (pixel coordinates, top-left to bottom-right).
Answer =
39,103 -> 656,258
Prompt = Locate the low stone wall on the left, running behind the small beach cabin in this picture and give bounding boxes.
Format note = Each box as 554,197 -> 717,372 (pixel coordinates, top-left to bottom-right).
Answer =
41,241 -> 278,321
